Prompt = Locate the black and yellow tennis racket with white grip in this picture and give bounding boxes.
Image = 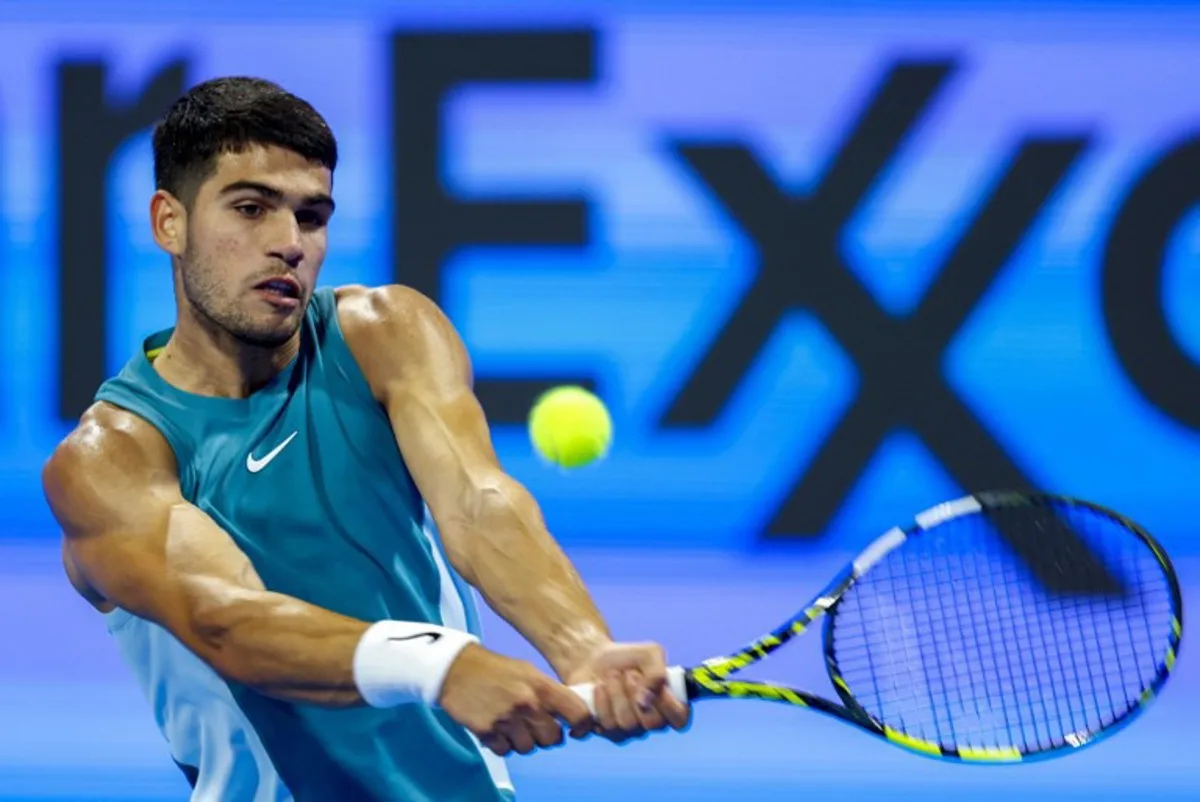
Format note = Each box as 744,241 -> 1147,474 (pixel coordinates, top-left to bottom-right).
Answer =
572,492 -> 1183,764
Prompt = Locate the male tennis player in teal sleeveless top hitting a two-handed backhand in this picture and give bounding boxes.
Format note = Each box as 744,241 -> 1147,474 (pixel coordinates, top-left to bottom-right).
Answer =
43,78 -> 688,802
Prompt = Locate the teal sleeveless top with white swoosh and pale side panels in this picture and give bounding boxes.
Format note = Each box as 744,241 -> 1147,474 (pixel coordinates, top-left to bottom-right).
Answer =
96,288 -> 514,802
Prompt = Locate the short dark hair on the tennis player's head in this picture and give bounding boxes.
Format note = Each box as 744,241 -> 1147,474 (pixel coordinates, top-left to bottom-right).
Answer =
154,77 -> 337,204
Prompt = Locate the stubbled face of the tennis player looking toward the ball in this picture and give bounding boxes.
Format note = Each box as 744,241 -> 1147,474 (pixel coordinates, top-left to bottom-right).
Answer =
180,146 -> 334,348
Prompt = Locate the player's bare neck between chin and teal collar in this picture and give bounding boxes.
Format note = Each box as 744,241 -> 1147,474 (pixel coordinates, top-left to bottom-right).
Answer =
154,306 -> 300,399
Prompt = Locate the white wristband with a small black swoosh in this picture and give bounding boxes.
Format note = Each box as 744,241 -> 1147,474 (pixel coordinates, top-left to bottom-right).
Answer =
354,621 -> 479,707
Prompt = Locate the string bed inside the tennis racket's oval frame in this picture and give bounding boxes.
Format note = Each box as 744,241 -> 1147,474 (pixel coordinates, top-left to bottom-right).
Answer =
833,508 -> 1174,752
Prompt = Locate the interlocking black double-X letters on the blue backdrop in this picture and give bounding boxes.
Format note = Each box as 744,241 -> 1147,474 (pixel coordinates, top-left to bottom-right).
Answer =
661,62 -> 1113,588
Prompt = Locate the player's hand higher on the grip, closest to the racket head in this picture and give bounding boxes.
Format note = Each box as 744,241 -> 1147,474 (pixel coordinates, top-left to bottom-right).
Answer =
566,644 -> 691,743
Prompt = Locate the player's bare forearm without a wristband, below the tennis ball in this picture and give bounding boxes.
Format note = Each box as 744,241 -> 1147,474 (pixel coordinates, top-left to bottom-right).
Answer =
448,478 -> 612,682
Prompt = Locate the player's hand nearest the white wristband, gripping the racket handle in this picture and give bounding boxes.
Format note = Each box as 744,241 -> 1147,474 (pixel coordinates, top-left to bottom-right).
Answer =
439,644 -> 594,758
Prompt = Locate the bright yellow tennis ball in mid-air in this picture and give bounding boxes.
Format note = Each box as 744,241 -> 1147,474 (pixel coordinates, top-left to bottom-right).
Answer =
529,385 -> 612,468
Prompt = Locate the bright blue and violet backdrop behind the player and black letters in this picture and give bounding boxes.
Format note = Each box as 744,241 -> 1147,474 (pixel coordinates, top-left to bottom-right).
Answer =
0,0 -> 1200,802
